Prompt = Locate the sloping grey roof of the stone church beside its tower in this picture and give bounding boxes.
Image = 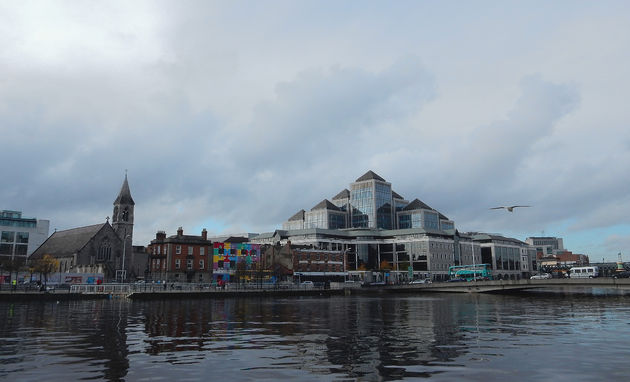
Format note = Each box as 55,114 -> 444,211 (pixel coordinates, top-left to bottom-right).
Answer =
30,223 -> 118,259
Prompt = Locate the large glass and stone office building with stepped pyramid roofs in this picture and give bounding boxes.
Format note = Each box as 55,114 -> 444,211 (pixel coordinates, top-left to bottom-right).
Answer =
250,171 -> 481,282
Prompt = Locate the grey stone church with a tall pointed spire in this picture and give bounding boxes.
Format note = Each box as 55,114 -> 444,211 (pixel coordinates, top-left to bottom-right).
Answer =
29,174 -> 139,281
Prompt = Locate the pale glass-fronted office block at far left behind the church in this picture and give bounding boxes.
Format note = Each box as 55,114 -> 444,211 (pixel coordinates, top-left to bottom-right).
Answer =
0,210 -> 50,263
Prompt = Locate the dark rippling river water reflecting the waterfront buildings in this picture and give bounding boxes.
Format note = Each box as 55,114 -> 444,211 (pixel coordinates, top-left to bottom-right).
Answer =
0,294 -> 630,382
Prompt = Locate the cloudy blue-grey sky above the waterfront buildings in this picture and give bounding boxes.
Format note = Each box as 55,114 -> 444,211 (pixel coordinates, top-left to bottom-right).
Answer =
0,0 -> 630,261
